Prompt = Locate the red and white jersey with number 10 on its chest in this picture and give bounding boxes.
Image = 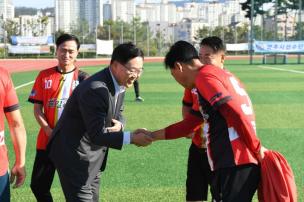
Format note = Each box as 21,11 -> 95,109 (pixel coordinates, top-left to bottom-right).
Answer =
28,67 -> 83,150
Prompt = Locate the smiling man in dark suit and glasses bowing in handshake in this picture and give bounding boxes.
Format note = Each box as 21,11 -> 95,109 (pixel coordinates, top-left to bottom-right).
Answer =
48,43 -> 152,202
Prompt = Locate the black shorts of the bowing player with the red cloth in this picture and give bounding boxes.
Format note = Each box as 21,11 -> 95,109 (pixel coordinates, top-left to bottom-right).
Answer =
211,164 -> 260,202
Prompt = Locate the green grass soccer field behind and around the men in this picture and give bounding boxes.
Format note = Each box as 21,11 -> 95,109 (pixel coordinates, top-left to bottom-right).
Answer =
6,61 -> 304,202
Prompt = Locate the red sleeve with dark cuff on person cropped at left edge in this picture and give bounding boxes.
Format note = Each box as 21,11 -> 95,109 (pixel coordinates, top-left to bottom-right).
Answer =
3,68 -> 19,112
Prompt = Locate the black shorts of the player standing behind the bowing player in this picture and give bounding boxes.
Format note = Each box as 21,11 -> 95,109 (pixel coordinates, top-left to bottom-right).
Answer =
186,143 -> 211,201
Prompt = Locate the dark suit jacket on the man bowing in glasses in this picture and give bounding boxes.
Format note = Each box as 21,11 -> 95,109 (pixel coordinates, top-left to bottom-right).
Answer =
48,68 -> 124,185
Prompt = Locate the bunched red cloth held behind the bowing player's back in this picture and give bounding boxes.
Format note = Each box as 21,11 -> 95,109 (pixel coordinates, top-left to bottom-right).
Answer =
258,150 -> 297,202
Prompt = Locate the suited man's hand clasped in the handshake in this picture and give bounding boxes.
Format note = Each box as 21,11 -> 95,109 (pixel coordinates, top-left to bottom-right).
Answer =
131,128 -> 153,147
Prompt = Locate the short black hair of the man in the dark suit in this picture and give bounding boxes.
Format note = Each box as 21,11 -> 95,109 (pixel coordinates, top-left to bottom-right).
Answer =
111,42 -> 144,65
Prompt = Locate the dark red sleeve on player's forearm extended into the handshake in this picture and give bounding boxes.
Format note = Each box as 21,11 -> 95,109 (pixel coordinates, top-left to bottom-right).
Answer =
165,113 -> 204,139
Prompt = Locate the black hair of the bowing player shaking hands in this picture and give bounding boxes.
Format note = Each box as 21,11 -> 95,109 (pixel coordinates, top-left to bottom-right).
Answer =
164,41 -> 199,69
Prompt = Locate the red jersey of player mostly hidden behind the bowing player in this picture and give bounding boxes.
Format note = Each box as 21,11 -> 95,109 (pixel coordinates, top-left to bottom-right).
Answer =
183,88 -> 206,148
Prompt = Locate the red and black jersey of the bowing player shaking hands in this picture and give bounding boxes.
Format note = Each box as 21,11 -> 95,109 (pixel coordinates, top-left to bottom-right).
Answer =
195,65 -> 260,170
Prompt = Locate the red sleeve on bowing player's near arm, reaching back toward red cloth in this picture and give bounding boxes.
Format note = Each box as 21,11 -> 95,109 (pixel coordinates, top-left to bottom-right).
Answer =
196,68 -> 261,153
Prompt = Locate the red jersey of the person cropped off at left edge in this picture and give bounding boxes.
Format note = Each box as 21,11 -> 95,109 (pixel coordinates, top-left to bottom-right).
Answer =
0,67 -> 19,176
